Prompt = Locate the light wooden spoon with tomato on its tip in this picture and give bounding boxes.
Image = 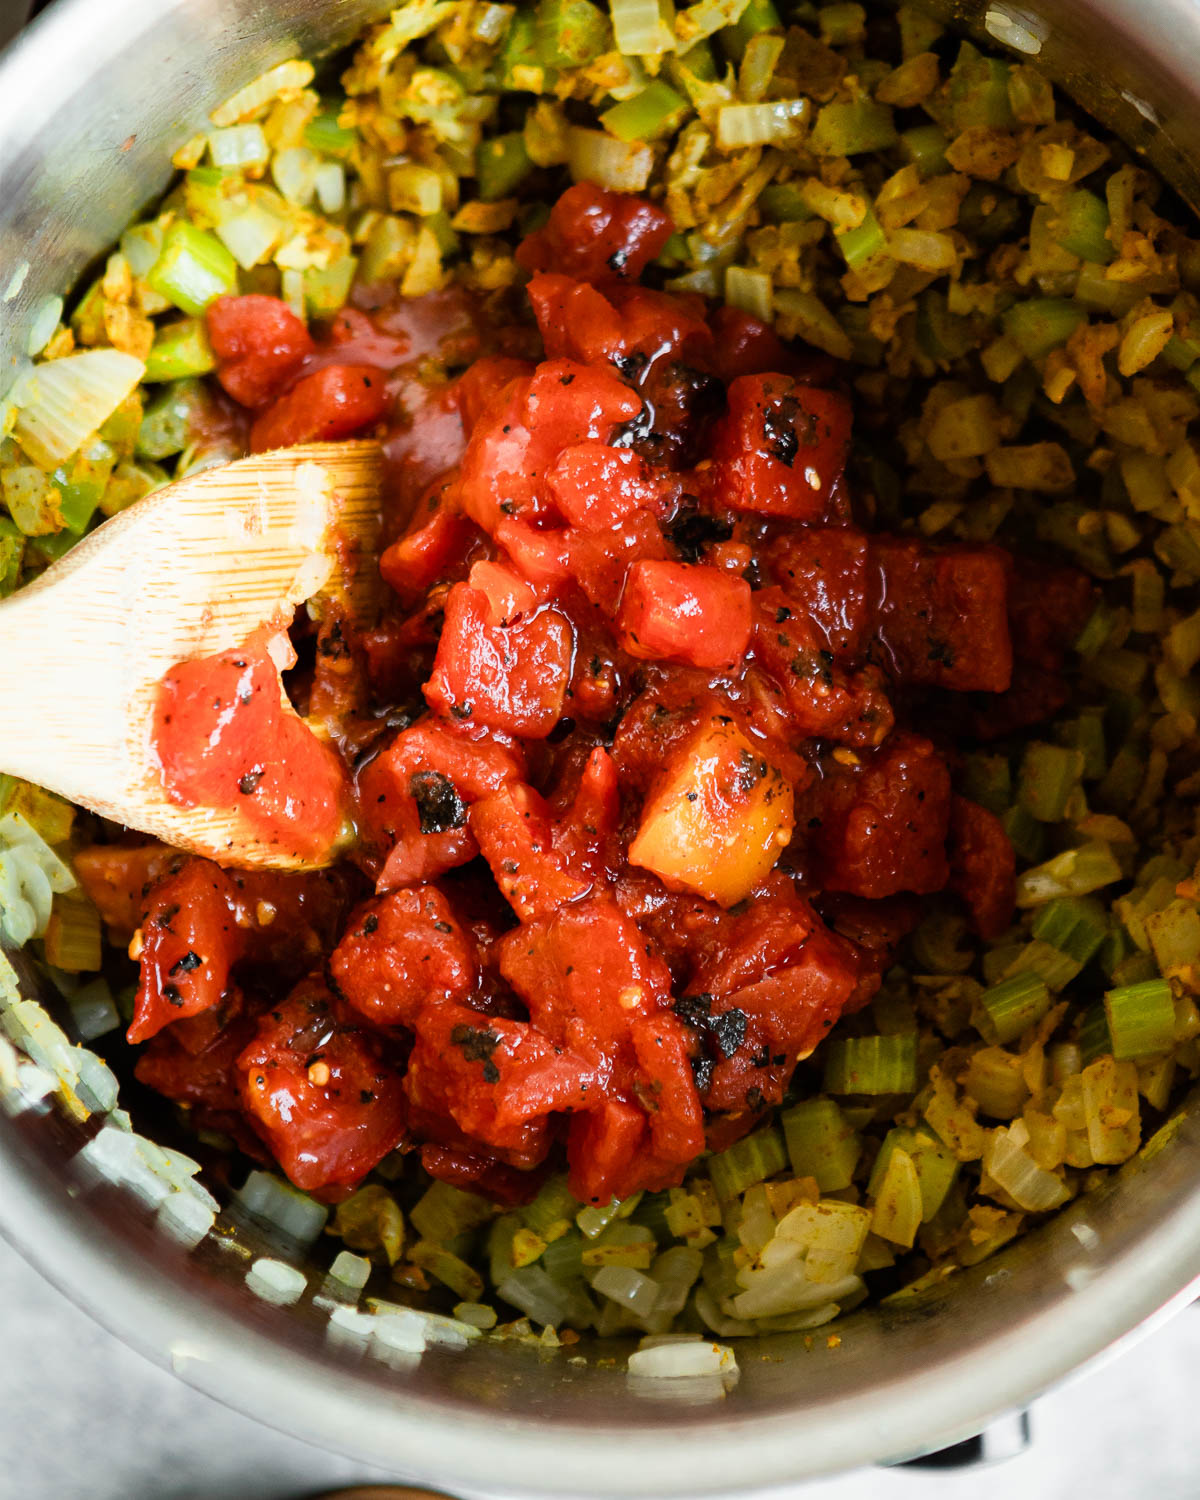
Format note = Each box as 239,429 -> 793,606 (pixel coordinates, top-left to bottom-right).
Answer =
0,443 -> 383,869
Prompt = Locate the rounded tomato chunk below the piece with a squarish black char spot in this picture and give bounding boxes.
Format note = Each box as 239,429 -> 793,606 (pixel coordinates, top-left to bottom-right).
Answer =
329,885 -> 476,1026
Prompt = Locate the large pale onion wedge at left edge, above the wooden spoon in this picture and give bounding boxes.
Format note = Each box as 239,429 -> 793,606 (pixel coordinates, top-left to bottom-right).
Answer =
12,350 -> 146,470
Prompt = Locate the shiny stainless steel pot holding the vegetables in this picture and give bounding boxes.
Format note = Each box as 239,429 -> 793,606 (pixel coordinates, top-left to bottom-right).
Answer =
0,0 -> 1200,1497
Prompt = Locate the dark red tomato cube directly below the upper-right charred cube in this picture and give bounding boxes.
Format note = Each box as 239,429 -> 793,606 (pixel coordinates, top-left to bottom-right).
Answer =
767,527 -> 876,659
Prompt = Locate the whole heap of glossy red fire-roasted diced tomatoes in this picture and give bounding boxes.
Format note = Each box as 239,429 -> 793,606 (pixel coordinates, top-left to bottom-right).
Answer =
131,183 -> 1038,1206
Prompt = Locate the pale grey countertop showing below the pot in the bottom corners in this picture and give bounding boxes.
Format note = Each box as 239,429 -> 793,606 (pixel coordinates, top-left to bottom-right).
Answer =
0,1241 -> 1200,1500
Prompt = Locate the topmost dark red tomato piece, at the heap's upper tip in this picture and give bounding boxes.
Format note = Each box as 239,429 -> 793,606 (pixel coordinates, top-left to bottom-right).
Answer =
516,183 -> 674,284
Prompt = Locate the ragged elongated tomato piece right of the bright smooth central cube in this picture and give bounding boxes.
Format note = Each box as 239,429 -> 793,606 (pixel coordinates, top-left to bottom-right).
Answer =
753,588 -> 894,747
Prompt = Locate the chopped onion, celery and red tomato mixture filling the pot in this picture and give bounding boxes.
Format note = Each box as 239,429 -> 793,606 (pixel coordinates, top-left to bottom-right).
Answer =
0,0 -> 1200,1337
